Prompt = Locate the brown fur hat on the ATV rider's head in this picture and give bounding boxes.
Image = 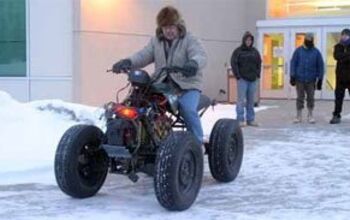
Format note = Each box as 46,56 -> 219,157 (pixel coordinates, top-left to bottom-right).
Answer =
157,6 -> 182,27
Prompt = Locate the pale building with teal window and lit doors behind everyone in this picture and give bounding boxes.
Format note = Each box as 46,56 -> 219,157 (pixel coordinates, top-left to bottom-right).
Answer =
0,0 -> 350,105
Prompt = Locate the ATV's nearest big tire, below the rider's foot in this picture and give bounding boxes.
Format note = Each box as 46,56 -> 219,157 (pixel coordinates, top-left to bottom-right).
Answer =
154,131 -> 203,211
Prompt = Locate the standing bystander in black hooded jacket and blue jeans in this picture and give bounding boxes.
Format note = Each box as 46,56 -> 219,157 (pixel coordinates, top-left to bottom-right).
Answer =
231,32 -> 261,126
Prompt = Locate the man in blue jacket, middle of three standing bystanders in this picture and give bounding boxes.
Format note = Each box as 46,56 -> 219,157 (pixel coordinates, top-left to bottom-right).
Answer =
290,33 -> 324,124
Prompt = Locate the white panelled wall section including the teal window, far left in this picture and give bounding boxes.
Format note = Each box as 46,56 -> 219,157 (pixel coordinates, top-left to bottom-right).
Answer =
0,0 -> 73,101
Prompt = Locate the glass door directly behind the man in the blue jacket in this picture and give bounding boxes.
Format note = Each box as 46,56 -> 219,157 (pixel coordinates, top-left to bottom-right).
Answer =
288,28 -> 322,99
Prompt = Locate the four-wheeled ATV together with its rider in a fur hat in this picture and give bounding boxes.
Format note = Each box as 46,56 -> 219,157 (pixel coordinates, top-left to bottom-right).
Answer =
55,7 -> 244,211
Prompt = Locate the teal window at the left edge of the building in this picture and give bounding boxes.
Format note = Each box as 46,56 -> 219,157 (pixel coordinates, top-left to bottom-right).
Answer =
0,0 -> 26,77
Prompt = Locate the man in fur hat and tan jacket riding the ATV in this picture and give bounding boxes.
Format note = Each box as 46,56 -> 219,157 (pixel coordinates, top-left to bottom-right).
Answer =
112,6 -> 207,143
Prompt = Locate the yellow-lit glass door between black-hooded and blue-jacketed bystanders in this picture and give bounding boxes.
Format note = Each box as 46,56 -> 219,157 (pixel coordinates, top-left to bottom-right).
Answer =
259,29 -> 289,98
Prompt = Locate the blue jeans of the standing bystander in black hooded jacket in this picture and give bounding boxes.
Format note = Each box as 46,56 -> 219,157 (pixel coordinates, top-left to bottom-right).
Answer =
236,79 -> 257,122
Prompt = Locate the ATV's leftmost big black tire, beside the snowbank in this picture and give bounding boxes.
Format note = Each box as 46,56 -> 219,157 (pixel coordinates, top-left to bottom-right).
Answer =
55,125 -> 108,198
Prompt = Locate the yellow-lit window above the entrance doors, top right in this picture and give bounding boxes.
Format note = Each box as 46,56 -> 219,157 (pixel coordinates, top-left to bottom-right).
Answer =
268,0 -> 350,18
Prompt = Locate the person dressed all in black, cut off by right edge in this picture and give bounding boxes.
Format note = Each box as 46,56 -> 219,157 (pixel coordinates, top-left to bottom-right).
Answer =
330,29 -> 350,124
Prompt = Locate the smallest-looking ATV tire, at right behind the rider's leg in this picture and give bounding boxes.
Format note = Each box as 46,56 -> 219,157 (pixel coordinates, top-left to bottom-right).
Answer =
208,119 -> 243,182
